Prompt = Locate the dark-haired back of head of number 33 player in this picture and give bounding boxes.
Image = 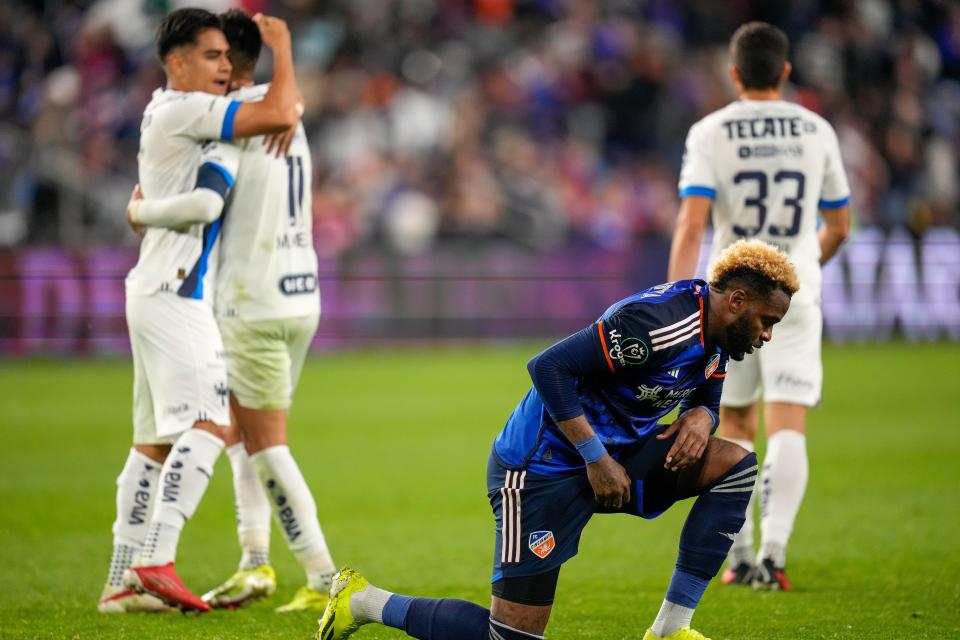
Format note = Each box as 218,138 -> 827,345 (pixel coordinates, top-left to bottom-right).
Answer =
730,22 -> 790,89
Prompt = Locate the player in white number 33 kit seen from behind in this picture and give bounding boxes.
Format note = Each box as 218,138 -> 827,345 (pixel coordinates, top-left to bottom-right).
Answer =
668,22 -> 850,590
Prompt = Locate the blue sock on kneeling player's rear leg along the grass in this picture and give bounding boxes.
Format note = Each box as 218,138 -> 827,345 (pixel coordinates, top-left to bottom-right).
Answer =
383,594 -> 490,640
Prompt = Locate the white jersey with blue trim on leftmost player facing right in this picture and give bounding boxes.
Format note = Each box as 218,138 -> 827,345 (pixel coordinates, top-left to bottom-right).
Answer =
126,89 -> 240,301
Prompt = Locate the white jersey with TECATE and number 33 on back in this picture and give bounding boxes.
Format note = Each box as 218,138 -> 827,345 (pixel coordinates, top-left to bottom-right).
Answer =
680,100 -> 850,303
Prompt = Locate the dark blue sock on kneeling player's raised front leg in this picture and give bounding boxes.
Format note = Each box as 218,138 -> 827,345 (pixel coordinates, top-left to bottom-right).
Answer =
666,453 -> 757,609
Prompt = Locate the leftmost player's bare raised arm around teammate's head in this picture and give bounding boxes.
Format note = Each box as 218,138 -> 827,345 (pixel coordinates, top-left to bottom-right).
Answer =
232,13 -> 303,138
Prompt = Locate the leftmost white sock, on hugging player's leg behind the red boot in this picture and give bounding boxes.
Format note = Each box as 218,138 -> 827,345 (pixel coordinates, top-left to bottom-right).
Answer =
107,449 -> 160,587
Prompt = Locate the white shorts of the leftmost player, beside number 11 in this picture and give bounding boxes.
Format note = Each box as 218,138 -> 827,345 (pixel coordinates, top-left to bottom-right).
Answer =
126,292 -> 230,444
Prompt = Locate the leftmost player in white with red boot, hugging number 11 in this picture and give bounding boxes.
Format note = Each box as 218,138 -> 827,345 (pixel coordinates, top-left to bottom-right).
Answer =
98,9 -> 299,613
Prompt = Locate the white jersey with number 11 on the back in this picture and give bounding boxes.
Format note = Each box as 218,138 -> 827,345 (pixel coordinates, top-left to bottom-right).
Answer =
216,85 -> 320,320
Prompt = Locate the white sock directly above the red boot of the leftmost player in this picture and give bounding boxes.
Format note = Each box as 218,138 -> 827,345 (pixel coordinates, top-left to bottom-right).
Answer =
140,429 -> 223,566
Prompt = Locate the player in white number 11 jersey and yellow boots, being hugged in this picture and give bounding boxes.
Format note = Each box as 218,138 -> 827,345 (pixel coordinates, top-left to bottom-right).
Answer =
203,10 -> 336,613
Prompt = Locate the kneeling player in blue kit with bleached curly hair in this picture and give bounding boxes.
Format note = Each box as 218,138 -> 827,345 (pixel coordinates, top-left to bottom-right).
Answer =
317,240 -> 799,640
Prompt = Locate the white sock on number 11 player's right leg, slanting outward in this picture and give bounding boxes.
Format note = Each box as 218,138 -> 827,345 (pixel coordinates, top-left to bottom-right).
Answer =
250,445 -> 336,591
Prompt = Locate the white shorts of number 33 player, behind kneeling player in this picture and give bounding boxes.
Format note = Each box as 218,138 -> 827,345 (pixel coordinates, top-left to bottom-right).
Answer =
720,303 -> 823,407
